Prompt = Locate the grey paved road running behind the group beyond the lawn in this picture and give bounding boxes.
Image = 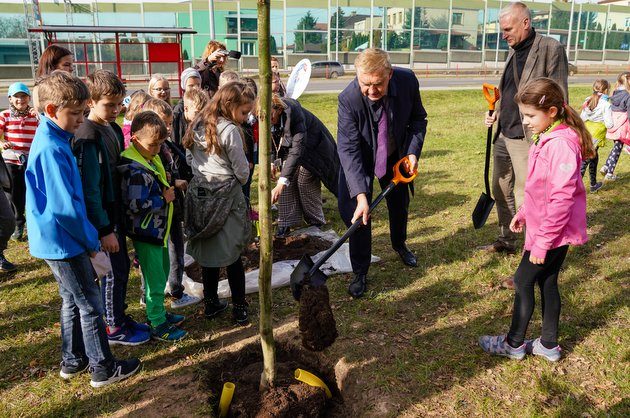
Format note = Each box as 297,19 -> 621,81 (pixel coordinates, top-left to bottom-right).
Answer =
0,75 -> 613,109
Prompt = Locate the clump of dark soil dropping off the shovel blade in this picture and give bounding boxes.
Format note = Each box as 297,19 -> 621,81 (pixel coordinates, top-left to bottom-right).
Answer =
299,286 -> 338,351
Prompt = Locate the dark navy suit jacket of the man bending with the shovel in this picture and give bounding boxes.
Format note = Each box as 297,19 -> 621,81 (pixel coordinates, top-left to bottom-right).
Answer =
337,68 -> 427,198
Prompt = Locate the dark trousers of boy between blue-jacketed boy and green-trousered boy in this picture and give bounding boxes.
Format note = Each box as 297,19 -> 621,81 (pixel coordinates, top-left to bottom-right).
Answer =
101,232 -> 131,327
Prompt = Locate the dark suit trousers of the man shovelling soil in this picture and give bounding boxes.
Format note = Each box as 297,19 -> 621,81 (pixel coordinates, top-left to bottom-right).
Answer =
337,157 -> 409,274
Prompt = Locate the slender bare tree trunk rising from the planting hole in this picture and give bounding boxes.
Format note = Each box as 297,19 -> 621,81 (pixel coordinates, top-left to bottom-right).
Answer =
258,0 -> 276,390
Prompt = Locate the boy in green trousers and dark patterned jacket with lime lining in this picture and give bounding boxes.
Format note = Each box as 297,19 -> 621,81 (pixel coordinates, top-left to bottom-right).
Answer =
118,111 -> 186,341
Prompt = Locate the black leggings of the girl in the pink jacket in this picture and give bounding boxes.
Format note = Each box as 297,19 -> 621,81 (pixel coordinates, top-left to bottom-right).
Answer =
508,245 -> 569,347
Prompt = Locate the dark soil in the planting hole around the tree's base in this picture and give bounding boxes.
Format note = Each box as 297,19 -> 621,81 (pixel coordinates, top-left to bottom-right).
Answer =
204,342 -> 342,418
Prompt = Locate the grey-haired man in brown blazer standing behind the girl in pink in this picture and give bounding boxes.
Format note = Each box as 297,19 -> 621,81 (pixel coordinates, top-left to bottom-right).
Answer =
481,2 -> 569,287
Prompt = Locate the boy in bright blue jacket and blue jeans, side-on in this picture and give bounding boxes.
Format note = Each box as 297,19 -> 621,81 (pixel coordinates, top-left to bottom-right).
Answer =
25,70 -> 140,387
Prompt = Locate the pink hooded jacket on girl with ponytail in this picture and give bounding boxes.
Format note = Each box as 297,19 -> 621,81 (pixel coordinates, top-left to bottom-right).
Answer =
516,124 -> 588,259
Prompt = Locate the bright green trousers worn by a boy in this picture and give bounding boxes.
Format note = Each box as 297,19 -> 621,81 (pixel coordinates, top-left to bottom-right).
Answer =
133,241 -> 170,327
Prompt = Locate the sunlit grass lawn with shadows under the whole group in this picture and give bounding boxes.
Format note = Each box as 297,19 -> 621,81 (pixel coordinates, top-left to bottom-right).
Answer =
0,88 -> 630,417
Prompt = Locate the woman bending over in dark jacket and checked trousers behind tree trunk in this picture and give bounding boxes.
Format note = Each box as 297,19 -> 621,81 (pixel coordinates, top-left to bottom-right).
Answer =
271,94 -> 339,238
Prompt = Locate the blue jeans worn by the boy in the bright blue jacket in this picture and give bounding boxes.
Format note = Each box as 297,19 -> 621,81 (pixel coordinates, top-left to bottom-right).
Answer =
46,253 -> 114,371
